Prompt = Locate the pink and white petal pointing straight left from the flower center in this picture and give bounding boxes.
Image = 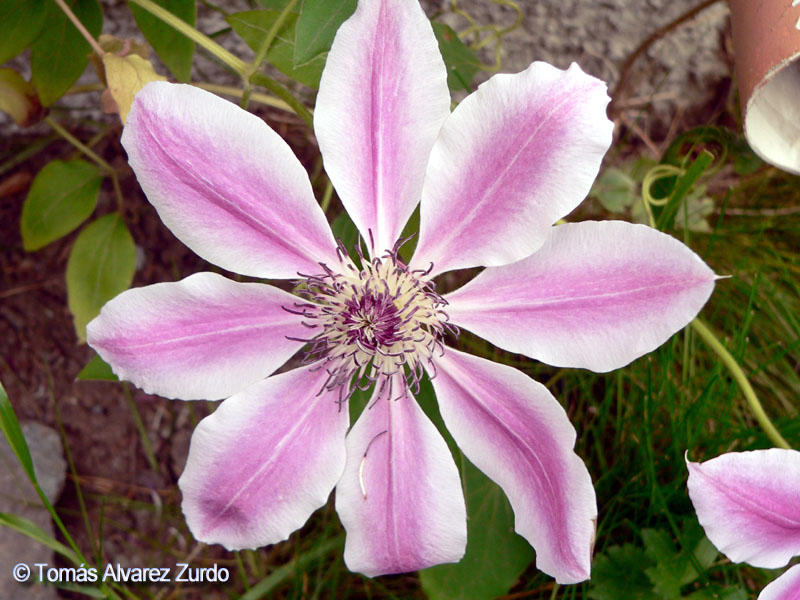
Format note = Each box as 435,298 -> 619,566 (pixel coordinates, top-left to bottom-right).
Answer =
86,273 -> 309,400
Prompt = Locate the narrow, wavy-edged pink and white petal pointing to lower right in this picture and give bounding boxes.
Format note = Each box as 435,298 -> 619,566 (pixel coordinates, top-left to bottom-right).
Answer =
432,348 -> 597,583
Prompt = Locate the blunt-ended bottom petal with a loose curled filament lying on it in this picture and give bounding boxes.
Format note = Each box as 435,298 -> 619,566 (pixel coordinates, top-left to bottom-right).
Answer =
336,377 -> 467,577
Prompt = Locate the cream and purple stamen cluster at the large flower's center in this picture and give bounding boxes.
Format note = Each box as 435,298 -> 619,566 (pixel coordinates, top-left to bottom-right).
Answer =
284,250 -> 456,400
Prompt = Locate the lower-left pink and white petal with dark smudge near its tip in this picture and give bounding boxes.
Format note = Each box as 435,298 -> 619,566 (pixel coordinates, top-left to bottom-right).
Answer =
178,365 -> 349,550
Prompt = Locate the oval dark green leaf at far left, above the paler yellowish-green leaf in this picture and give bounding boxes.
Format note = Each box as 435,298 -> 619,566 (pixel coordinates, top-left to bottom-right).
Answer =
19,160 -> 103,252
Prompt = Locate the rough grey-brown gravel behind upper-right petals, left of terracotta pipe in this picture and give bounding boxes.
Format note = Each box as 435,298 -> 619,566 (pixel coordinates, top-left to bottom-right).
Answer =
428,0 -> 729,96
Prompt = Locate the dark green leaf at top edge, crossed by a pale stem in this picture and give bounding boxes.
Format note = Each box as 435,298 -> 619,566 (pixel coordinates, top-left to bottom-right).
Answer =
129,0 -> 197,82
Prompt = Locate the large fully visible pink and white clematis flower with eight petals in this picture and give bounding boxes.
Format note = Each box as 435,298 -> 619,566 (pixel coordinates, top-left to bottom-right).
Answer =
88,0 -> 715,583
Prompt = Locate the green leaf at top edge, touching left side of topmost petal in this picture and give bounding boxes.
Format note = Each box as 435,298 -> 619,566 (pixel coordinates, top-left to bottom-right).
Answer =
294,0 -> 356,66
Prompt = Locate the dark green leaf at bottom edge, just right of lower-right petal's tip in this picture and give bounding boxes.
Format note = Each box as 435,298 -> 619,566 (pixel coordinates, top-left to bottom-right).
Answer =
588,544 -> 658,600
